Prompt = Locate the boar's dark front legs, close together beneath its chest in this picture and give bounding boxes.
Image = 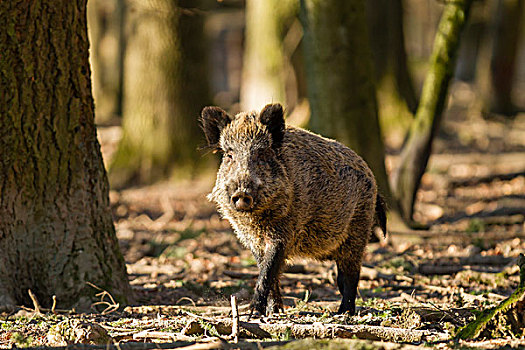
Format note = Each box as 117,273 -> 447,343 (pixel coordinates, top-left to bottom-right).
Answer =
251,242 -> 284,315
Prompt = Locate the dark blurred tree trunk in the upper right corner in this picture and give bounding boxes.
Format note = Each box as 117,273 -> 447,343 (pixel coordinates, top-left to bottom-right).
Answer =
478,0 -> 524,115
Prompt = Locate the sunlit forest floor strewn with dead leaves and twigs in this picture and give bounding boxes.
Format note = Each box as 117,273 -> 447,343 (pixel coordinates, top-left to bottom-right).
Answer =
0,84 -> 525,349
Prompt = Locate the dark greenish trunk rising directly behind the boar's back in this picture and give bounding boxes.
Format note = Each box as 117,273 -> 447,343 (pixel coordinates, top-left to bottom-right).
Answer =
300,0 -> 388,194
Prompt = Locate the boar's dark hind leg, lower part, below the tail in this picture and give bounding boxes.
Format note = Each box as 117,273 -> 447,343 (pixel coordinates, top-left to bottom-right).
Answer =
337,261 -> 361,315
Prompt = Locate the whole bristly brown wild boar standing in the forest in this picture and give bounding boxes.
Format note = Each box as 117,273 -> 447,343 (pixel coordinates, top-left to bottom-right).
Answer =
201,104 -> 386,314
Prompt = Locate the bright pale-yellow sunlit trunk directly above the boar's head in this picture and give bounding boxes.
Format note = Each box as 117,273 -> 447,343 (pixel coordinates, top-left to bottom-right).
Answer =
241,0 -> 297,110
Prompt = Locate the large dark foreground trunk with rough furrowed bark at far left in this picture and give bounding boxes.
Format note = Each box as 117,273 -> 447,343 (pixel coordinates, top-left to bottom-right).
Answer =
0,0 -> 130,308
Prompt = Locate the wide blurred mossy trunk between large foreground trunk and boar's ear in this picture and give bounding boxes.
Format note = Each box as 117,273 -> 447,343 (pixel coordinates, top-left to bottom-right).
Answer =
109,0 -> 209,187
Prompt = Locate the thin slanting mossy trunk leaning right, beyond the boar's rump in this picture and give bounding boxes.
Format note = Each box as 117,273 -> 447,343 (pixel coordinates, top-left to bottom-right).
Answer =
392,0 -> 472,222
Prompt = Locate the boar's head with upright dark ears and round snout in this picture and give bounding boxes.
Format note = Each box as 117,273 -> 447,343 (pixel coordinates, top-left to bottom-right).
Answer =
201,104 -> 291,217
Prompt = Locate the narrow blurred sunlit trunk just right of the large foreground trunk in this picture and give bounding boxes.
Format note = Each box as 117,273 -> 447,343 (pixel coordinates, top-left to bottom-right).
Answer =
87,0 -> 124,123
